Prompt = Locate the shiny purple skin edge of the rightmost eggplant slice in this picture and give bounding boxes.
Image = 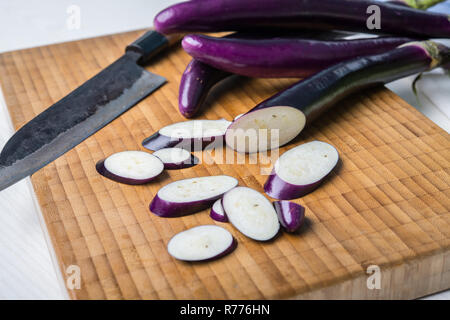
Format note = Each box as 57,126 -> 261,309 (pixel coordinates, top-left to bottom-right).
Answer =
264,170 -> 328,200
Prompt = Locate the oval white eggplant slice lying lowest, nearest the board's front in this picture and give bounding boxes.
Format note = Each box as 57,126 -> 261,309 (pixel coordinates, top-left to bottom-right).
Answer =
167,225 -> 237,261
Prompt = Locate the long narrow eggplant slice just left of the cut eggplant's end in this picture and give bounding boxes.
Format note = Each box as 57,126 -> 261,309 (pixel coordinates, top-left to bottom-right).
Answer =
142,119 -> 231,151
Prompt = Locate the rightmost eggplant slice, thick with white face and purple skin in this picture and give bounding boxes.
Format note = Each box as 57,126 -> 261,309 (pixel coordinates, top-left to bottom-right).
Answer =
264,141 -> 339,200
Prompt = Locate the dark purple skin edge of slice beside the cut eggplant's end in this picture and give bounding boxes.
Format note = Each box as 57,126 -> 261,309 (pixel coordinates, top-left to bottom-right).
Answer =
142,132 -> 223,152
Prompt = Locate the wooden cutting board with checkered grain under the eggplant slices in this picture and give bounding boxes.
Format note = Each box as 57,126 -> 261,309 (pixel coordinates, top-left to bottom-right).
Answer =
0,31 -> 450,299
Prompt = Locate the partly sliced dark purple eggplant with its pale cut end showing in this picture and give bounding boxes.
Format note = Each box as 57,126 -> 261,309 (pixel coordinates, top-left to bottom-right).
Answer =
225,41 -> 450,153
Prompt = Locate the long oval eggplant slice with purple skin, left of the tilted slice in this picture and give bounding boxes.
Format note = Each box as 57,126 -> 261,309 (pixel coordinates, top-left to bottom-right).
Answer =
150,175 -> 238,218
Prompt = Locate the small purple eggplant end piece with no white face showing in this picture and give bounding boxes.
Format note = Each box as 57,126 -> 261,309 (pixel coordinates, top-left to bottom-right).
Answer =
273,201 -> 305,232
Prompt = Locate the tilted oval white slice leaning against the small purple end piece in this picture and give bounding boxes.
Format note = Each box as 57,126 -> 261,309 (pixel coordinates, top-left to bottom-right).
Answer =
222,187 -> 280,241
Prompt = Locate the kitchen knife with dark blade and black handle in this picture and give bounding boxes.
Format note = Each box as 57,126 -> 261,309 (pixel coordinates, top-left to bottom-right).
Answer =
0,31 -> 180,190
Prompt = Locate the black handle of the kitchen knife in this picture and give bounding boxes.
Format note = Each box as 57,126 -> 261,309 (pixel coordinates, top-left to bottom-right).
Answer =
125,30 -> 181,64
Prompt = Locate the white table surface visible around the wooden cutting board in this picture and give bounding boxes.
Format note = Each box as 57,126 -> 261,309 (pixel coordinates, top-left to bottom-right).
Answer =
0,0 -> 450,300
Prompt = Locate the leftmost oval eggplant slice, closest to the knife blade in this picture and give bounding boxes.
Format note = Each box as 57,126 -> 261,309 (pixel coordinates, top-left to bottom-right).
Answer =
96,151 -> 164,185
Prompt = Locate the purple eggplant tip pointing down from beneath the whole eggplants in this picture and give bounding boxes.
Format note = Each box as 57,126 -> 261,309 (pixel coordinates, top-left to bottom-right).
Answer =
178,59 -> 232,118
